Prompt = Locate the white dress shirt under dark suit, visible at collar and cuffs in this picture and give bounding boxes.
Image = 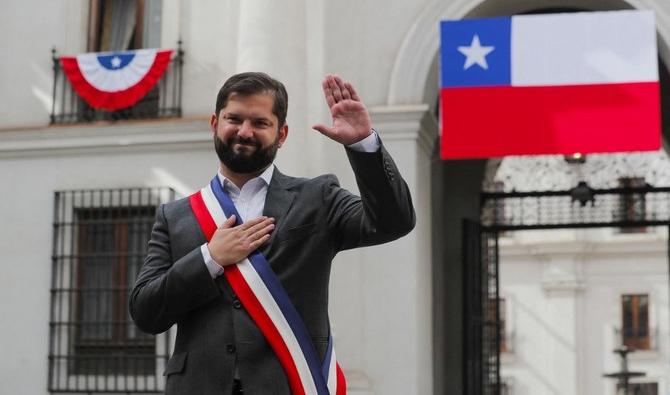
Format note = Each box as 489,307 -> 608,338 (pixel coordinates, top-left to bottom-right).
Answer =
200,130 -> 380,278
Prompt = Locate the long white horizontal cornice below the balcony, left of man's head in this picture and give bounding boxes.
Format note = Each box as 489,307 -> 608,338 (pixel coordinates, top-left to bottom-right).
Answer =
0,119 -> 212,159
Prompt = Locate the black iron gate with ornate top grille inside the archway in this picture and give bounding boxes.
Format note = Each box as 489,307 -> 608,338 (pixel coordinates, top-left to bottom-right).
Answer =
463,182 -> 670,395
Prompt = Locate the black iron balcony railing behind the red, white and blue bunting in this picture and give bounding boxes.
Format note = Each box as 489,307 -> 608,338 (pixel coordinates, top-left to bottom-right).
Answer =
51,41 -> 184,125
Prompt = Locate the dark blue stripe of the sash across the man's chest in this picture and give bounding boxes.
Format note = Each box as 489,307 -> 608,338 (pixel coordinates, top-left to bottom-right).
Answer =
210,176 -> 329,394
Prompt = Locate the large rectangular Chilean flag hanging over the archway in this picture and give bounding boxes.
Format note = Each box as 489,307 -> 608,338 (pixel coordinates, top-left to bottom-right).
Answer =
440,11 -> 661,159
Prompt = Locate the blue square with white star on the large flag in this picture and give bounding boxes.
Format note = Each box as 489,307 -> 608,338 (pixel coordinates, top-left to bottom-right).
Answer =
440,17 -> 511,87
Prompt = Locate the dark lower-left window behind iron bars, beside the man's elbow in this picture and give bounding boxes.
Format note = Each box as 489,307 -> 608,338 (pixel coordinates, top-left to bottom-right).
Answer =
73,206 -> 156,375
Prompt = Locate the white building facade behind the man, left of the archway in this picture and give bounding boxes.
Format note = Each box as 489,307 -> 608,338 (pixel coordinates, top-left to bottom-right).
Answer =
0,0 -> 670,394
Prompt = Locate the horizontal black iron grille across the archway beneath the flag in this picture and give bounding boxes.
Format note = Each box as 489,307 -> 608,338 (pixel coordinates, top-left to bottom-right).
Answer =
481,184 -> 670,230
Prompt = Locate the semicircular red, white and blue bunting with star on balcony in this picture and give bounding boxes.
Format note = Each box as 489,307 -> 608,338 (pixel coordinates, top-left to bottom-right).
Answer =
60,49 -> 172,111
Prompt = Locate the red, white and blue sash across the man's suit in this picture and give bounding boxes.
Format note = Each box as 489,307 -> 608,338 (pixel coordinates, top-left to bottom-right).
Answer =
189,176 -> 346,395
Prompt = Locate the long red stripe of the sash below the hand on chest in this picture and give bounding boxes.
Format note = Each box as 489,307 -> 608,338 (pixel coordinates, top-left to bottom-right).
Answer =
223,265 -> 305,395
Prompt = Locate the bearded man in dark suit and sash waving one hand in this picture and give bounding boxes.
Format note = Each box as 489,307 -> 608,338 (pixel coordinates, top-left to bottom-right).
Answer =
130,73 -> 415,395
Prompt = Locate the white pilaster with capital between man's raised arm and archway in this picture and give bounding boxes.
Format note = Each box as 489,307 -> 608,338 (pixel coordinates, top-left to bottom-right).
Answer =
361,105 -> 434,395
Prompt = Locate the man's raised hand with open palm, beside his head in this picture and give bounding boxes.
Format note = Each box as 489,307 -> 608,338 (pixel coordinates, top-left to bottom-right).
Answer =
312,74 -> 372,145
